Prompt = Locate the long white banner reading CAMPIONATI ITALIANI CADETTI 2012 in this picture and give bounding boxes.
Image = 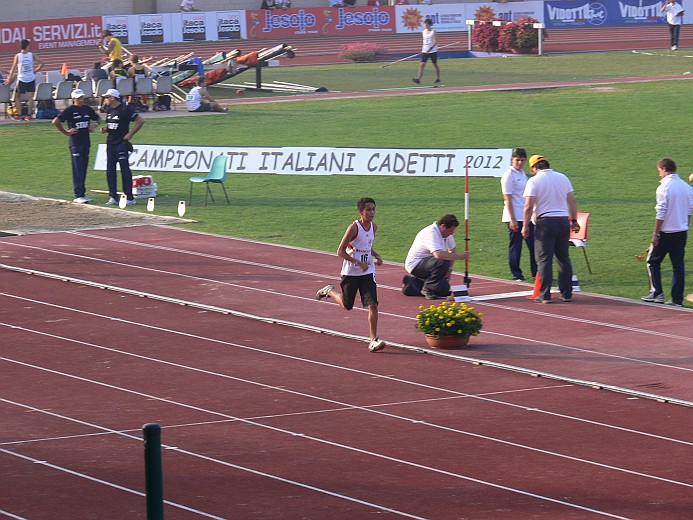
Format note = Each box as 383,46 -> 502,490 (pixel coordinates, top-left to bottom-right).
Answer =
94,144 -> 511,177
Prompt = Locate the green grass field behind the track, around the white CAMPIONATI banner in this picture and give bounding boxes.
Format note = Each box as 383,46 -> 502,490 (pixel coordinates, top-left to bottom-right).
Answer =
0,52 -> 693,298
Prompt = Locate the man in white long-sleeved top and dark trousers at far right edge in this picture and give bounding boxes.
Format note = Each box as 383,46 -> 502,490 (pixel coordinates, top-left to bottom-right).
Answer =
642,157 -> 693,307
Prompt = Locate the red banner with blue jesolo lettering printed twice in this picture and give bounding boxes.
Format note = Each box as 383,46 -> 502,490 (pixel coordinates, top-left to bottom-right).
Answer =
246,6 -> 396,40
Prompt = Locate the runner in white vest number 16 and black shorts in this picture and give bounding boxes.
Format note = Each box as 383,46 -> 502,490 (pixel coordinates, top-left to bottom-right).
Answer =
315,197 -> 385,352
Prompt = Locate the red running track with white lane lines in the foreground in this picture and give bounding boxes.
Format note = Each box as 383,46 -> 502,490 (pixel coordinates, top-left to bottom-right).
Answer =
0,227 -> 693,519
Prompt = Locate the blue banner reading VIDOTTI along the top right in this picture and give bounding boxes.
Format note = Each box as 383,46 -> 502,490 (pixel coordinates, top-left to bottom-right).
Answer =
544,0 -> 666,28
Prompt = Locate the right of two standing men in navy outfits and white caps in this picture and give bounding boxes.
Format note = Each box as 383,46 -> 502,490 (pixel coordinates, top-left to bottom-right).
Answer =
101,88 -> 144,206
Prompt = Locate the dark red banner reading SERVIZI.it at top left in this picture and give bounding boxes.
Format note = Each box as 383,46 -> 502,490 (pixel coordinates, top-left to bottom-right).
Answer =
0,16 -> 101,52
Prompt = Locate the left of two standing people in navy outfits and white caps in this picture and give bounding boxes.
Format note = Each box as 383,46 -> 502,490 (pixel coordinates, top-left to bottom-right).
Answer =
53,89 -> 101,204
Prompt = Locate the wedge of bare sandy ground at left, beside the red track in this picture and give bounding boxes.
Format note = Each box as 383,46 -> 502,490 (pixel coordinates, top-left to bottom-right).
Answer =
0,191 -> 193,236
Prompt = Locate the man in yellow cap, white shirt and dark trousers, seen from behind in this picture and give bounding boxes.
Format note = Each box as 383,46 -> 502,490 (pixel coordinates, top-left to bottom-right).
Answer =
522,155 -> 580,303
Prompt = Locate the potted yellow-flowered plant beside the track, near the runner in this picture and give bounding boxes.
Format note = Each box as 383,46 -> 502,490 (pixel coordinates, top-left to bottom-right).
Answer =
416,301 -> 483,348
